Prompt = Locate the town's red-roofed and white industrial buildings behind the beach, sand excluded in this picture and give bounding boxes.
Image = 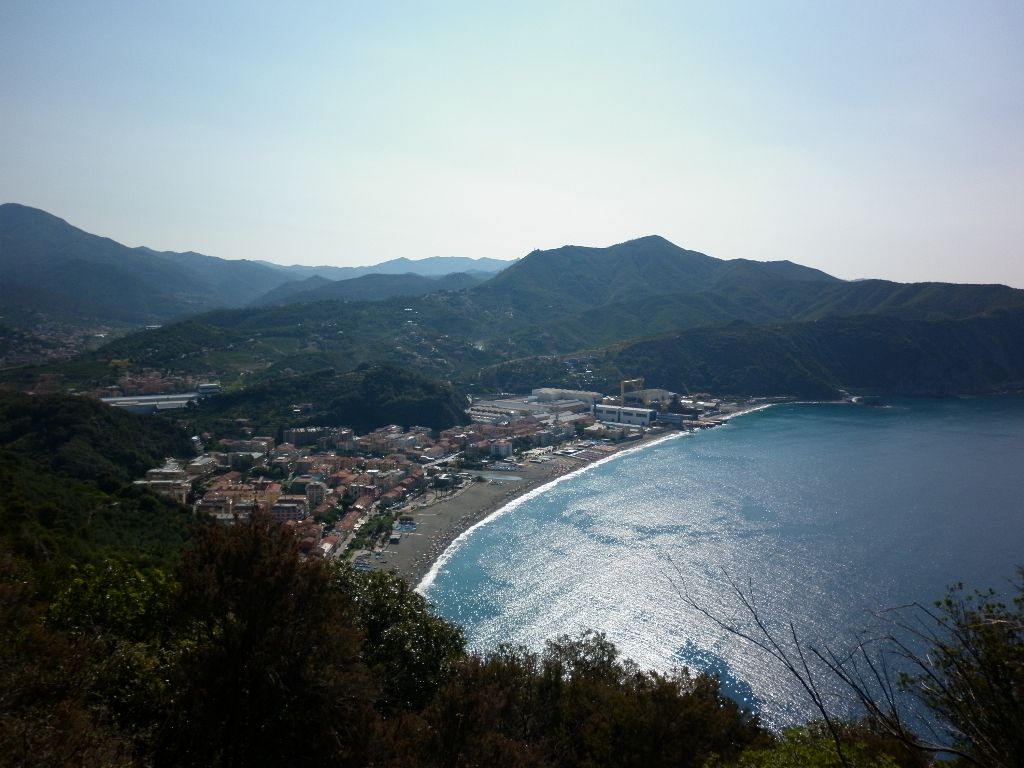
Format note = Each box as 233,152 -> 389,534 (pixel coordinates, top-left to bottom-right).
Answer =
137,388 -> 729,557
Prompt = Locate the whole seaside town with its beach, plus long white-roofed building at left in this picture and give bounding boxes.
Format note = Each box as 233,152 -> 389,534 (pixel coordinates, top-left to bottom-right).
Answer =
128,380 -> 740,584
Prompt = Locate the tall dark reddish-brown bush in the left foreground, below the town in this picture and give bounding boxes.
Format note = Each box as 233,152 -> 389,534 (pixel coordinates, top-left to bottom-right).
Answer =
155,516 -> 373,768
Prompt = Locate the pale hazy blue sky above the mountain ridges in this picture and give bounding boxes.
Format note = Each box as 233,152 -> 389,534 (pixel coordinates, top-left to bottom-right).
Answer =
0,0 -> 1024,288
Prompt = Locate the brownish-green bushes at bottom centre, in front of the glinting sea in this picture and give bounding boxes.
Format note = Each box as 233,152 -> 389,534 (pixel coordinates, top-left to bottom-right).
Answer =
377,633 -> 765,767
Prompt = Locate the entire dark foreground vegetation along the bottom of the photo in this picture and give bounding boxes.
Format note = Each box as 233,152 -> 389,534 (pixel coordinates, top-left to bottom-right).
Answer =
6,499 -> 1024,768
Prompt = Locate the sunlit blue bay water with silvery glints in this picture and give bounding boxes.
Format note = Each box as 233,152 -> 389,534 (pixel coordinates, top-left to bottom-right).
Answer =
420,397 -> 1024,726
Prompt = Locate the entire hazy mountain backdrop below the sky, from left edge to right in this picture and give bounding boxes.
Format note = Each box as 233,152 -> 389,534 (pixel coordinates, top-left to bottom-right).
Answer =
0,201 -> 1024,397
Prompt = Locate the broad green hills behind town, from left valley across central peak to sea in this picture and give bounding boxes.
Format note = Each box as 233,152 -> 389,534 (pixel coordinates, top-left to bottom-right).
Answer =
6,231 -> 1024,403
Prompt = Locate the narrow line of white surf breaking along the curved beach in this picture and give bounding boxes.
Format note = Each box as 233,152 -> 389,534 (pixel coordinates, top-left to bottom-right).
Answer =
402,402 -> 778,594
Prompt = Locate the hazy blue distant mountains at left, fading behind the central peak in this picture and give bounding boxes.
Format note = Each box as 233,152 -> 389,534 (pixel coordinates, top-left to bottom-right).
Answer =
0,203 -> 508,326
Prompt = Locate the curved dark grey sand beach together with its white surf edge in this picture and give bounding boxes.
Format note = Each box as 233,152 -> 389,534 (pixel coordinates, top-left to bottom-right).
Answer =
372,403 -> 775,592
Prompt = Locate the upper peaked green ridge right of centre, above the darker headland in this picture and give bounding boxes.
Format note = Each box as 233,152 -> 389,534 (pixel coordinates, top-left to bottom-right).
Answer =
470,237 -> 1024,331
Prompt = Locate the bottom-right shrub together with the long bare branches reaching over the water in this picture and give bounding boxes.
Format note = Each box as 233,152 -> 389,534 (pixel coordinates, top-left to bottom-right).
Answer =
680,569 -> 1024,768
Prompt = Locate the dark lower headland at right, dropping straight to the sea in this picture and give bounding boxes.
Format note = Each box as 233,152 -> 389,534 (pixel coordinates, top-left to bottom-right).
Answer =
612,309 -> 1024,398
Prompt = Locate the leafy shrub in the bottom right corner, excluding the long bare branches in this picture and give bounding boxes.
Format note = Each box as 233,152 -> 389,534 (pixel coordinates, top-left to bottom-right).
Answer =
819,570 -> 1024,768
